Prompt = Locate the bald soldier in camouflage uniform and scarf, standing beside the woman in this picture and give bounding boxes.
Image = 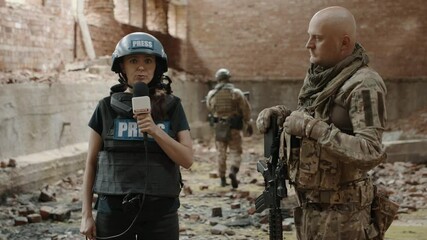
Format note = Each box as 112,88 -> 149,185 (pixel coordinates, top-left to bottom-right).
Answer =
256,6 -> 397,240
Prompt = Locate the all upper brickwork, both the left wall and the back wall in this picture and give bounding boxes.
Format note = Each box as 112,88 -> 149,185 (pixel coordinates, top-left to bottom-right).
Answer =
0,0 -> 427,80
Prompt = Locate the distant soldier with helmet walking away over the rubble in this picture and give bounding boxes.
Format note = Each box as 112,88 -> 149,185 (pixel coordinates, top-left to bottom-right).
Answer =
206,68 -> 252,188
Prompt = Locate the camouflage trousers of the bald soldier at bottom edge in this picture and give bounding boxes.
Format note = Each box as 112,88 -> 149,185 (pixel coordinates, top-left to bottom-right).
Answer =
294,203 -> 373,240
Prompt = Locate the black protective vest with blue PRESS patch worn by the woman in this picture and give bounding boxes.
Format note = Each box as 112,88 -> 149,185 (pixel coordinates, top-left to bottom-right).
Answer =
94,92 -> 181,197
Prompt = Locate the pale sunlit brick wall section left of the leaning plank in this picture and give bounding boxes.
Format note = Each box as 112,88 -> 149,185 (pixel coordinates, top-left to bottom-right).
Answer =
0,0 -> 75,71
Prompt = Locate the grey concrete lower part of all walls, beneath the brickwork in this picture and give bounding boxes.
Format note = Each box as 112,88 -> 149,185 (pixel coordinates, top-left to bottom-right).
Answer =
0,73 -> 427,160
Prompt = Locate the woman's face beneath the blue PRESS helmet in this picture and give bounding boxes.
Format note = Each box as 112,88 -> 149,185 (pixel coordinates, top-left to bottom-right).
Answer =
121,54 -> 156,86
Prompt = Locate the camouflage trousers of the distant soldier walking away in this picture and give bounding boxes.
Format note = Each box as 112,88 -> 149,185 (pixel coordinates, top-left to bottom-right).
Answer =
215,129 -> 243,177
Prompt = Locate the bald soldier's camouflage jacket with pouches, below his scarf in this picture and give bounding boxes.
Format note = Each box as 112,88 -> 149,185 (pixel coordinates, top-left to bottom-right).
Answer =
288,67 -> 387,203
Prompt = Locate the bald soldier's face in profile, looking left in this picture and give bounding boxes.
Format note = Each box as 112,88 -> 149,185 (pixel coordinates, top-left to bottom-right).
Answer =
306,17 -> 341,68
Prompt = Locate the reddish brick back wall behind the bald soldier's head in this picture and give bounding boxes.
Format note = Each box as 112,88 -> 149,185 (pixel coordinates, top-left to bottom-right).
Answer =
186,0 -> 427,79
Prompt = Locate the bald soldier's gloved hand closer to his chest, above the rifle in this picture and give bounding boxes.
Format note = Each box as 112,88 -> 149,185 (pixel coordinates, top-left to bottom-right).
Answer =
283,111 -> 328,140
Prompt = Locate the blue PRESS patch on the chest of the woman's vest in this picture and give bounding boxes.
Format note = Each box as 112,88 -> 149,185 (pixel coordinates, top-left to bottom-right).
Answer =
113,119 -> 171,141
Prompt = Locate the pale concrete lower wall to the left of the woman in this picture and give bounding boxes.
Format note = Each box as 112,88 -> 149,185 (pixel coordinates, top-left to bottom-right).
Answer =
0,78 -> 114,160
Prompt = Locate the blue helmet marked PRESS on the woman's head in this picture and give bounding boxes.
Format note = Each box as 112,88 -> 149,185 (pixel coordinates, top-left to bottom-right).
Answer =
111,32 -> 168,88
